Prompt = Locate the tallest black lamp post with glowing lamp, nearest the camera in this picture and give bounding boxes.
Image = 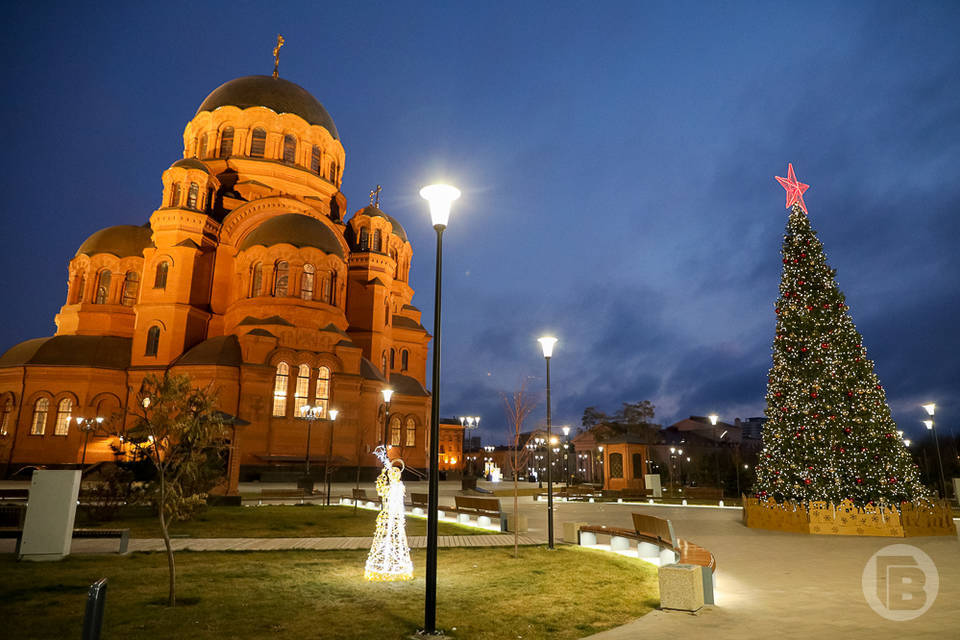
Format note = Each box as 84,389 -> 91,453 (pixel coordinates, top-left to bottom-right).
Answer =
420,184 -> 460,635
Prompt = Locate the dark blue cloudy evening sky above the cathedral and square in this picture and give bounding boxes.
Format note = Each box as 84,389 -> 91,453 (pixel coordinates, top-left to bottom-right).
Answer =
0,2 -> 960,440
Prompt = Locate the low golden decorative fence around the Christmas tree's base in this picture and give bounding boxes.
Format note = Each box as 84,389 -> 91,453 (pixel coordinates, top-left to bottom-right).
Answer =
743,498 -> 957,538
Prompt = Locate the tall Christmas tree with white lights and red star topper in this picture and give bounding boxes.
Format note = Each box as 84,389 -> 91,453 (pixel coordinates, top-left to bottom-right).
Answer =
757,165 -> 929,506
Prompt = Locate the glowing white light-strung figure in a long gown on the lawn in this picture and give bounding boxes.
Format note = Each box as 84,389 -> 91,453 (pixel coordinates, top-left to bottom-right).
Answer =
363,445 -> 413,581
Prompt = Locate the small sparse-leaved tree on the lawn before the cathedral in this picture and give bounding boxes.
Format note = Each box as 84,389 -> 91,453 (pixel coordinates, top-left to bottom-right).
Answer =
127,373 -> 227,607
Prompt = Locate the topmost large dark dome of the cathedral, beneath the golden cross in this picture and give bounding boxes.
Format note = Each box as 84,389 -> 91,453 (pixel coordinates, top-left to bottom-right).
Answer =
197,76 -> 339,140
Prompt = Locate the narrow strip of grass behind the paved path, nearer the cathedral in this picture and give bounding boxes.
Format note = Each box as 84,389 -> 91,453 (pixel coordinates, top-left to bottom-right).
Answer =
77,505 -> 496,538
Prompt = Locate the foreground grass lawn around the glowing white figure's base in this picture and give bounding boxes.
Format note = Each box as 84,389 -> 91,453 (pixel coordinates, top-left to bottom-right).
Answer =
0,546 -> 659,640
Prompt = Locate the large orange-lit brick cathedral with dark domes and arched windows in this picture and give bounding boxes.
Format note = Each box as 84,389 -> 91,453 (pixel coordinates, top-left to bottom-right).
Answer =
0,76 -> 454,486
